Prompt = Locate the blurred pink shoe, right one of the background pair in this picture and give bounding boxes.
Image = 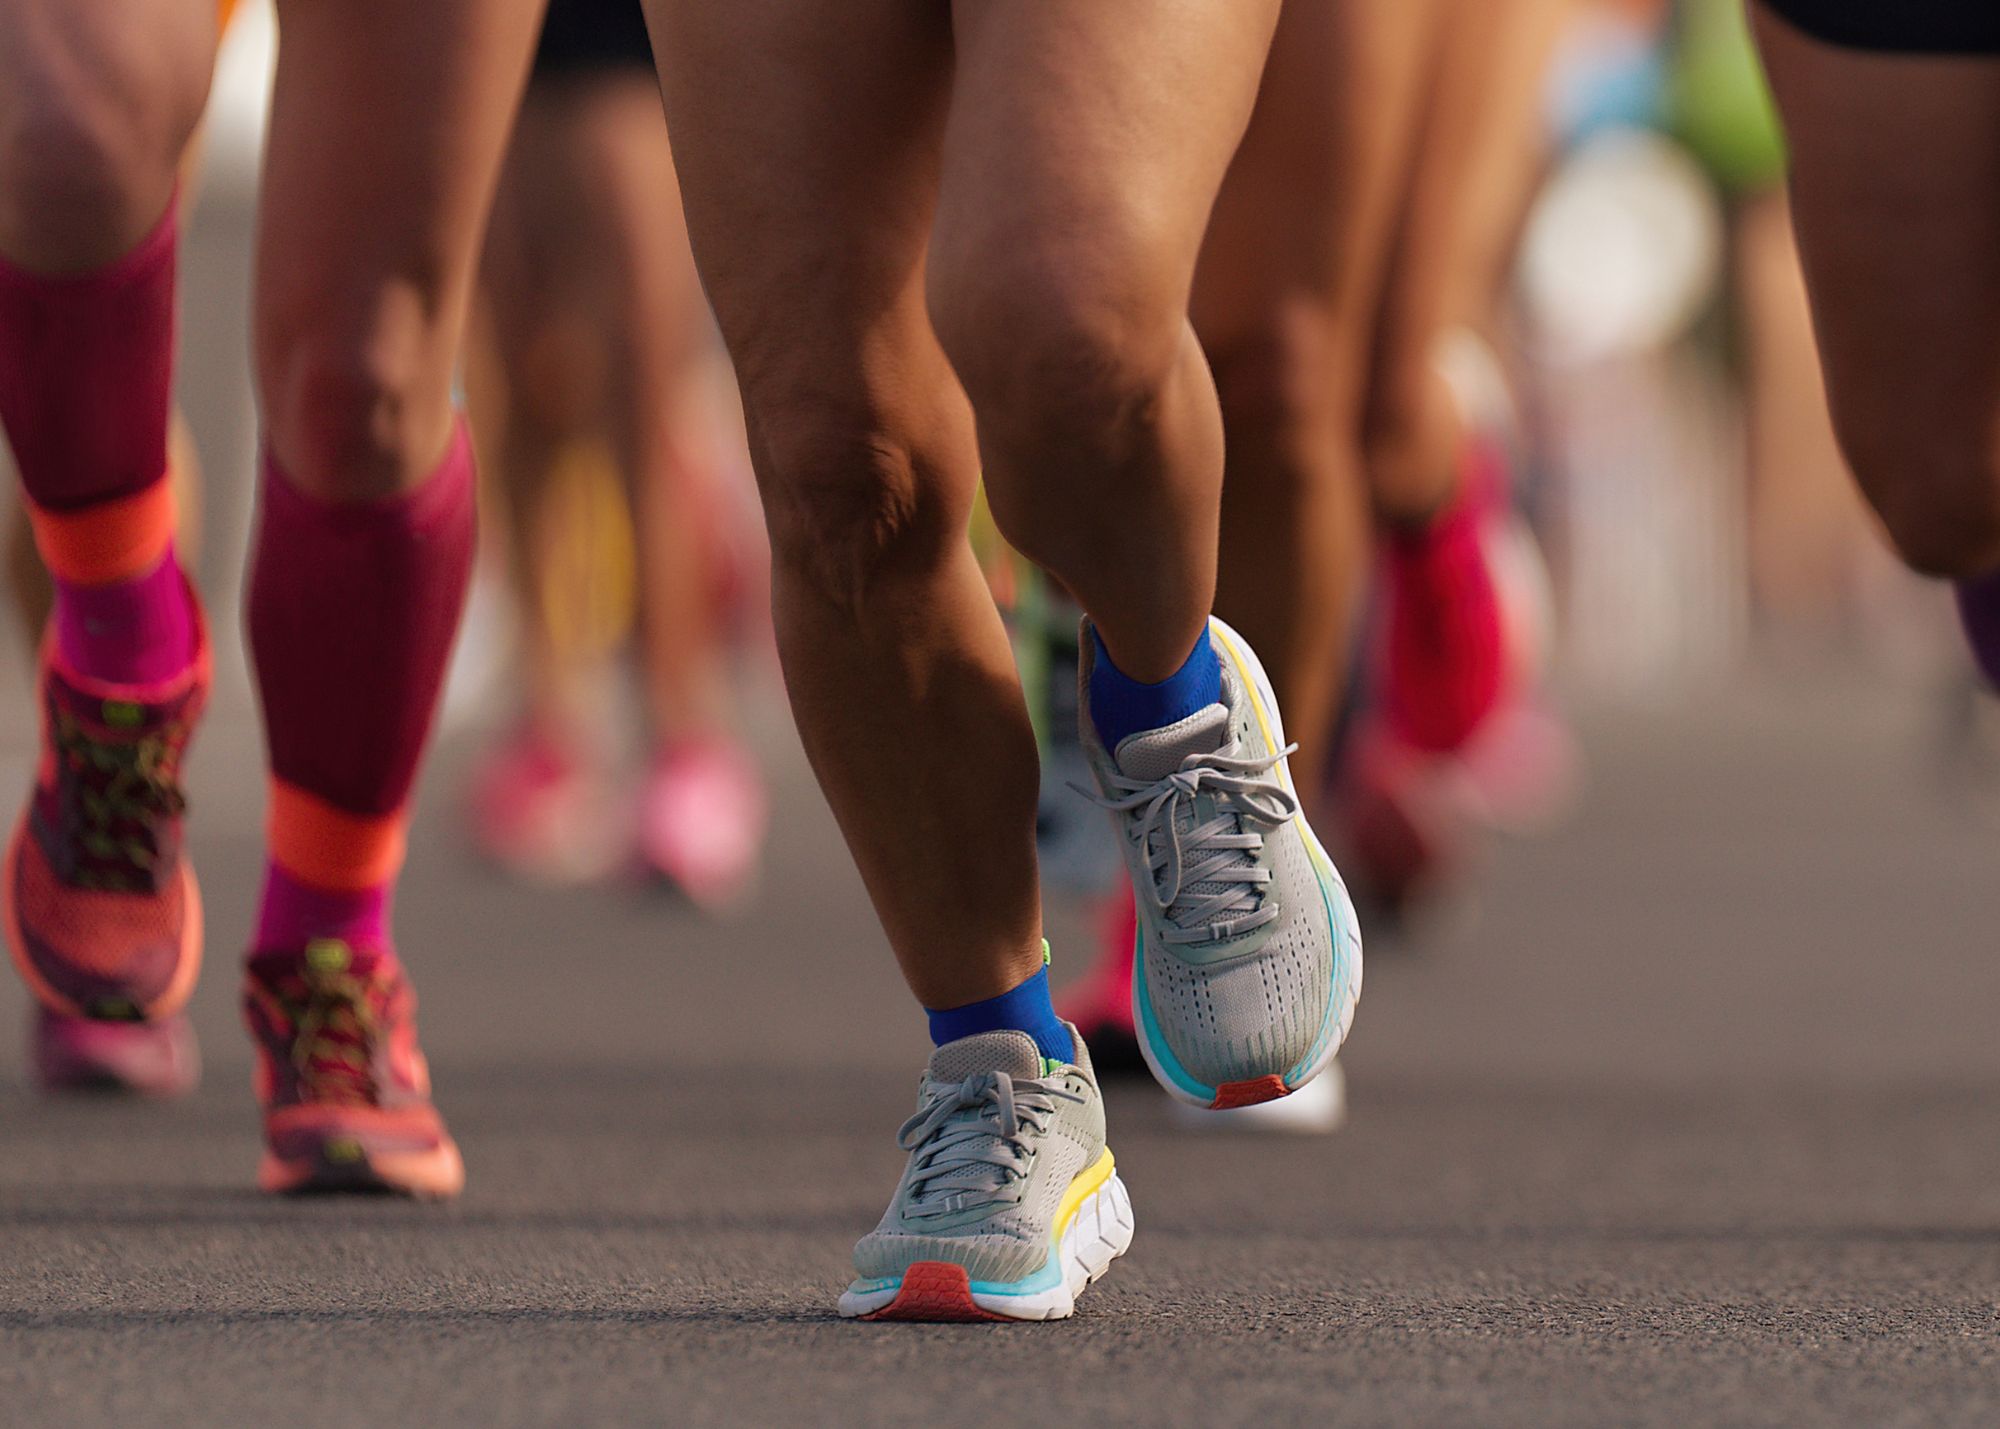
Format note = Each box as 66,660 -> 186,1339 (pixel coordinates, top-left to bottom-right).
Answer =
638,739 -> 768,913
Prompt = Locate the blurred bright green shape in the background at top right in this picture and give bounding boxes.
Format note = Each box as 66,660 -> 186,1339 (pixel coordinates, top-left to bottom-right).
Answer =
1668,0 -> 1784,192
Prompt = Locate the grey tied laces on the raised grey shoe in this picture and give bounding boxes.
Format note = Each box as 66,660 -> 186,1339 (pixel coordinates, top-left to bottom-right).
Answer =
1070,745 -> 1298,943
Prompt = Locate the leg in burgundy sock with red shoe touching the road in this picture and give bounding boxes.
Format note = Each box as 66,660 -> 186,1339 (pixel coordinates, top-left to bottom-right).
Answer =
246,0 -> 538,1195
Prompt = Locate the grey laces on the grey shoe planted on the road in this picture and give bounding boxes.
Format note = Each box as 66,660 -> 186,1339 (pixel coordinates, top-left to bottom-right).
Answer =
896,1071 -> 1084,1217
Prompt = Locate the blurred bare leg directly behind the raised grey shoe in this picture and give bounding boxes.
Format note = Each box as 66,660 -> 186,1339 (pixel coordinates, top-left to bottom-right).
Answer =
1194,0 -> 1436,801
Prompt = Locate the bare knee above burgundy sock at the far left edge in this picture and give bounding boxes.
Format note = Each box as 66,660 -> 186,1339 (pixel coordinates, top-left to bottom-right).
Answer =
0,60 -> 208,253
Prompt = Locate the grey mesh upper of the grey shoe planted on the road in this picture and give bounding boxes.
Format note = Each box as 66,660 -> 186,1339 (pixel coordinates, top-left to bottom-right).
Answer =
854,1033 -> 1104,1283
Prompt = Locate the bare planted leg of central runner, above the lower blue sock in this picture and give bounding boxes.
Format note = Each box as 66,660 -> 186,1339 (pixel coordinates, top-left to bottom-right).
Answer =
648,0 -> 1042,1009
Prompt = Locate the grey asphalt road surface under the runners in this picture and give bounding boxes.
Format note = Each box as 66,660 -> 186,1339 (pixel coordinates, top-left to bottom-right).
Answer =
0,660 -> 2000,1427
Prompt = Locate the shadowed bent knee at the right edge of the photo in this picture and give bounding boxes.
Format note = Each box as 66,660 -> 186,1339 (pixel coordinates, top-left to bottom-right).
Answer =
1836,412 -> 2000,578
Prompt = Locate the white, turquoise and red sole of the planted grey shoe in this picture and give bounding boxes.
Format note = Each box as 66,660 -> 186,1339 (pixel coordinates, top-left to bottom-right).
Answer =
840,1151 -> 1132,1323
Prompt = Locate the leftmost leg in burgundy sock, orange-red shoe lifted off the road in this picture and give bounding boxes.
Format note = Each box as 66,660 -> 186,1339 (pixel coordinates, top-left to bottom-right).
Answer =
0,0 -> 216,1093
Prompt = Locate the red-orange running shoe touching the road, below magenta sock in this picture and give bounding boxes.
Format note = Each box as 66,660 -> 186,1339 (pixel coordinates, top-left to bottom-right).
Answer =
244,939 -> 466,1199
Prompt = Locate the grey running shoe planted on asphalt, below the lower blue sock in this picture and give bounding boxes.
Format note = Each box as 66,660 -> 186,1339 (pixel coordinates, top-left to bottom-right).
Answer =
840,1029 -> 1132,1321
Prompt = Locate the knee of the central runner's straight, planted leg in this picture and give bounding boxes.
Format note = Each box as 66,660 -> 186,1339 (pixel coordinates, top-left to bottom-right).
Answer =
744,386 -> 968,616
